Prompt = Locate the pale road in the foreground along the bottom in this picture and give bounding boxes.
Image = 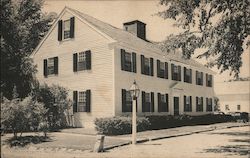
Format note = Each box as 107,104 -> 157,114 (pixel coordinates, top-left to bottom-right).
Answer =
2,126 -> 250,158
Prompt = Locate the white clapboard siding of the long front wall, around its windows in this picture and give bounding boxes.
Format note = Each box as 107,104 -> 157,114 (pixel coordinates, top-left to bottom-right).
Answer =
114,44 -> 214,115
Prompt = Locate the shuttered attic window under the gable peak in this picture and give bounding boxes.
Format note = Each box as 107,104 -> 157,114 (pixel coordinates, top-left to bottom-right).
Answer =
58,17 -> 75,41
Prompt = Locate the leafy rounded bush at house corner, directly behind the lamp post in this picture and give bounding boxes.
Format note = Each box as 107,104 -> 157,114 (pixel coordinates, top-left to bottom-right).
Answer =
95,117 -> 150,135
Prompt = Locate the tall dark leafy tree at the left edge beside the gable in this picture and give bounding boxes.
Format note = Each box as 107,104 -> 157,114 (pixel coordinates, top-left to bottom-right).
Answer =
0,0 -> 55,99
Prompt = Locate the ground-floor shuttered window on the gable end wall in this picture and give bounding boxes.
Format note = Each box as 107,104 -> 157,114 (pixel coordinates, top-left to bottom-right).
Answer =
73,90 -> 91,112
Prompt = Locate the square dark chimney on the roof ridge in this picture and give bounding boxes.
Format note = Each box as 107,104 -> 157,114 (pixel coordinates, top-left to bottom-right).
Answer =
123,20 -> 146,40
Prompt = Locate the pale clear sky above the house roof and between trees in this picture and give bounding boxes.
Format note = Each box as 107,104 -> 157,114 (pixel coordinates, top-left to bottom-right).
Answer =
43,0 -> 250,82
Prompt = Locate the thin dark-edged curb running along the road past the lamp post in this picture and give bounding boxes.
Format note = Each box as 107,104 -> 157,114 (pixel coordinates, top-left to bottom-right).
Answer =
104,124 -> 250,151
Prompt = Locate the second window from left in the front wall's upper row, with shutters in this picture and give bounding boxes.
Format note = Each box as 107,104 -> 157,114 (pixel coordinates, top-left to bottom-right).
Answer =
141,55 -> 154,76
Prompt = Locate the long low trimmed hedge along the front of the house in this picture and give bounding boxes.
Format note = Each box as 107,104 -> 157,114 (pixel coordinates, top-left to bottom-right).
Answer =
95,114 -> 236,135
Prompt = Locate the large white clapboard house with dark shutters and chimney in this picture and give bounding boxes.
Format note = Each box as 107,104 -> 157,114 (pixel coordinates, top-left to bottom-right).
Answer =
32,7 -> 214,127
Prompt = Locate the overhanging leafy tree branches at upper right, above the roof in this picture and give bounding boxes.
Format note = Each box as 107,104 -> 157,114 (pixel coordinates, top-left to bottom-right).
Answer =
158,0 -> 250,78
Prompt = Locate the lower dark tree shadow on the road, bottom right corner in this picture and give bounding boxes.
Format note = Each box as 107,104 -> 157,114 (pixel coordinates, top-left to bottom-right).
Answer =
205,145 -> 250,155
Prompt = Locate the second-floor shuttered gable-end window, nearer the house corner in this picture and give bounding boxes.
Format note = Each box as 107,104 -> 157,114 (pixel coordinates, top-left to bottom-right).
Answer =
73,50 -> 91,72
